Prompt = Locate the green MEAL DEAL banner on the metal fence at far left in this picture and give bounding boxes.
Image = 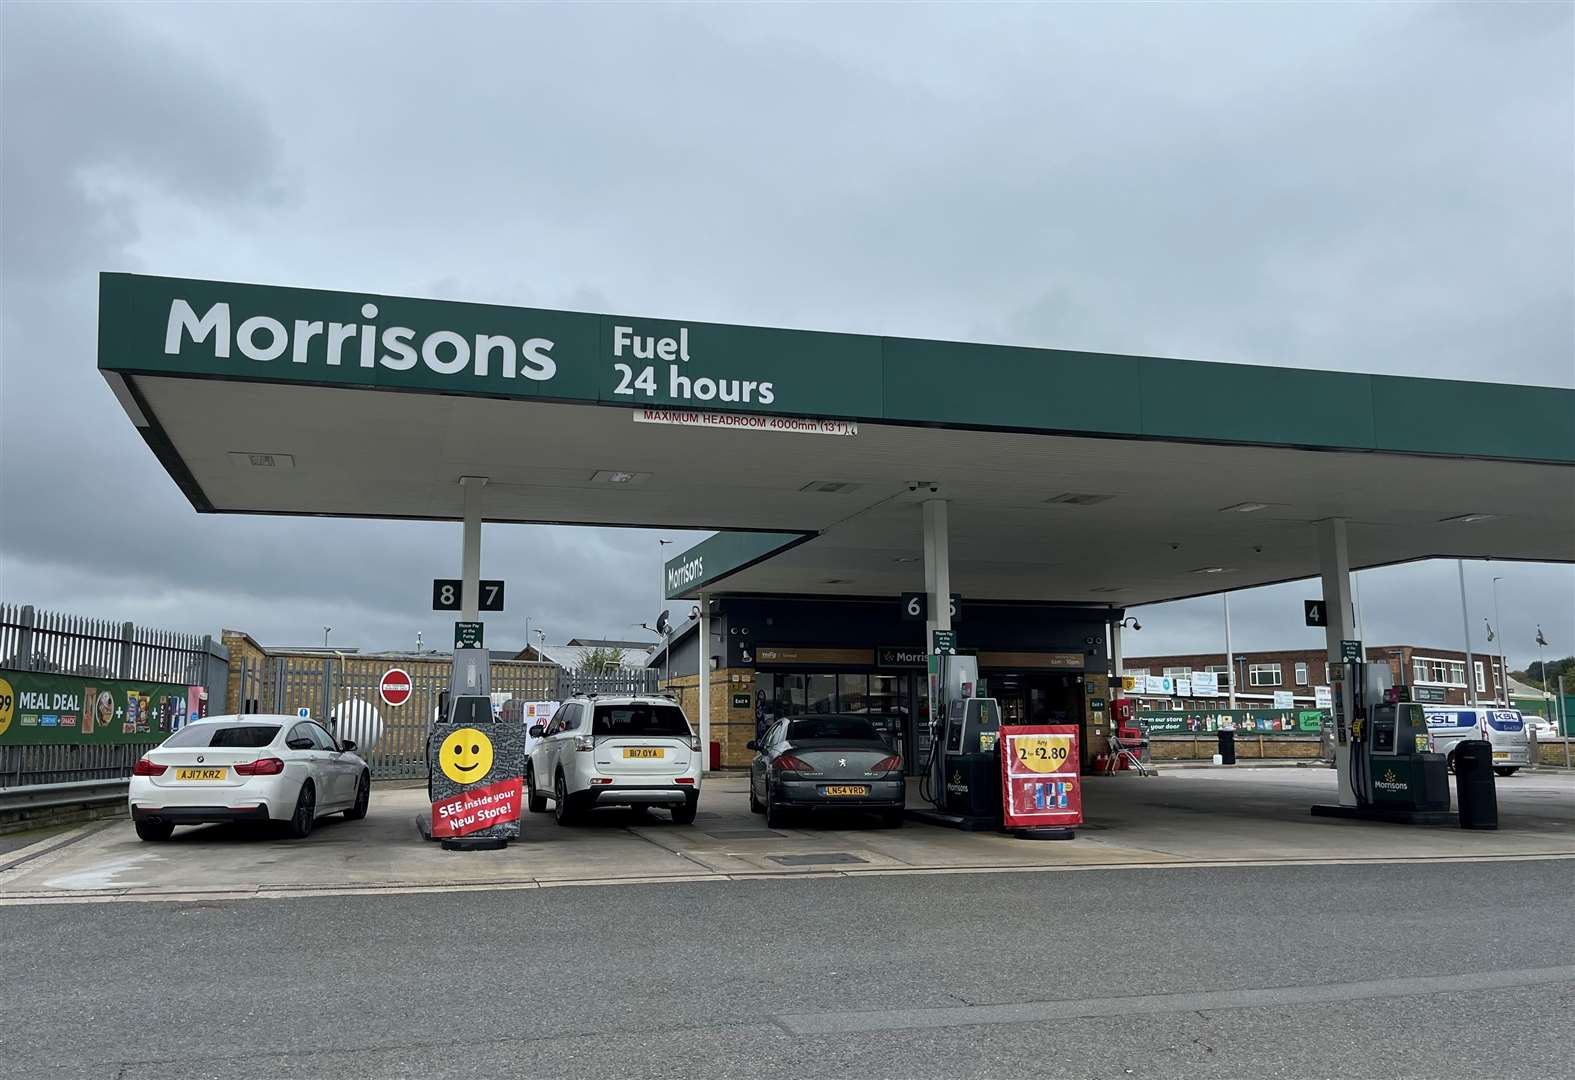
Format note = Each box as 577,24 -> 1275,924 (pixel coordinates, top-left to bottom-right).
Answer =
0,669 -> 208,746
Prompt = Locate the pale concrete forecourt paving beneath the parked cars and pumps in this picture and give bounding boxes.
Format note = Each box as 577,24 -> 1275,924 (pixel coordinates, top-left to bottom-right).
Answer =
0,768 -> 1575,905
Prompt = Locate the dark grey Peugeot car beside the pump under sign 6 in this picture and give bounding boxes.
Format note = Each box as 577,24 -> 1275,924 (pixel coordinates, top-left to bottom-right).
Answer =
750,715 -> 907,828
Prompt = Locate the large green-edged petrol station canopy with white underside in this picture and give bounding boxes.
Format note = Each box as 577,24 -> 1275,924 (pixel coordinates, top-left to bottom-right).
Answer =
98,274 -> 1575,606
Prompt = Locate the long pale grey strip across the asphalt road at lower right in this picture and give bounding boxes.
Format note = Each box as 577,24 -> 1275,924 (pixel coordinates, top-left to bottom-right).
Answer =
775,965 -> 1575,1036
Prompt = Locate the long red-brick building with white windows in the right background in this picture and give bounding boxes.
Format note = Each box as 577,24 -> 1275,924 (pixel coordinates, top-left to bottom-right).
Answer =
1120,645 -> 1507,710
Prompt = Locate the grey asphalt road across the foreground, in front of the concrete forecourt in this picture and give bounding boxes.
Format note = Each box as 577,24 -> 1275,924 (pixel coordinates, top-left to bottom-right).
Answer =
0,860 -> 1575,1080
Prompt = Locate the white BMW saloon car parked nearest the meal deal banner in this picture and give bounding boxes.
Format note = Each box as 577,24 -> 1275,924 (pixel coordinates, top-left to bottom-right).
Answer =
129,715 -> 372,841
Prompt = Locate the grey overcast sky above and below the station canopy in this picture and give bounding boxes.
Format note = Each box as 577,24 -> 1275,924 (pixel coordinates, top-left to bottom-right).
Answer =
0,2 -> 1575,668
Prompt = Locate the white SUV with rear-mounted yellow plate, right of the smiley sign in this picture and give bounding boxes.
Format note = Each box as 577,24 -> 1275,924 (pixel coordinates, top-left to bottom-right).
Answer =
524,694 -> 701,825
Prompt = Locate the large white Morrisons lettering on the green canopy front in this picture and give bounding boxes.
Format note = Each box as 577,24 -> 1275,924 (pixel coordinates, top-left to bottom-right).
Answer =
164,298 -> 558,383
